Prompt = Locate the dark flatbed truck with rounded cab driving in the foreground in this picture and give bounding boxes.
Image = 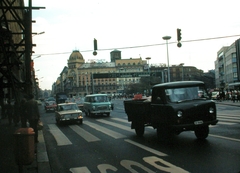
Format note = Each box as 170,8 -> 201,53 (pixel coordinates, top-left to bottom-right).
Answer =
124,81 -> 218,139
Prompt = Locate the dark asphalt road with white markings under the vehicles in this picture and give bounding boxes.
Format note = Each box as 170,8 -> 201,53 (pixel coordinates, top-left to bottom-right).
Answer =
39,100 -> 240,173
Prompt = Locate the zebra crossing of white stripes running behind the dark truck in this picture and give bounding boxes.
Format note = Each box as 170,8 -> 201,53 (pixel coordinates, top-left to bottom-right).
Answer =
48,114 -> 240,146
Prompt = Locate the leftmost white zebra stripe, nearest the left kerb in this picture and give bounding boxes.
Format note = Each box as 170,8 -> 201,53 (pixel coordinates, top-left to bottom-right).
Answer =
48,124 -> 72,146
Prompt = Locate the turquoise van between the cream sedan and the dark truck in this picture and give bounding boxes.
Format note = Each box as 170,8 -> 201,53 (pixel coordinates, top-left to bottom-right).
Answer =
83,94 -> 113,116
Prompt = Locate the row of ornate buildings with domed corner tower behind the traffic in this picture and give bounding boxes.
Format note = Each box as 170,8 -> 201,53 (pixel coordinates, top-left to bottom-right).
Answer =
53,50 -> 214,97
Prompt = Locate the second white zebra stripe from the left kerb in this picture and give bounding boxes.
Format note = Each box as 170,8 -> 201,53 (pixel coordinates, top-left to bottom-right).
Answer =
69,125 -> 100,142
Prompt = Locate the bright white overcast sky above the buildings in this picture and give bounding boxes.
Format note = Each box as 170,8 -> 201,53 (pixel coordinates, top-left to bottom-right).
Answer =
25,0 -> 240,90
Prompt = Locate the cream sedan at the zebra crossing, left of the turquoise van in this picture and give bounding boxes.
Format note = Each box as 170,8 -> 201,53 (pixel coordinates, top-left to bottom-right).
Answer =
55,103 -> 83,124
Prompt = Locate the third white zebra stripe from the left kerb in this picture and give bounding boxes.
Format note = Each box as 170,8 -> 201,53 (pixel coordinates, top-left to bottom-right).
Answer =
84,121 -> 126,139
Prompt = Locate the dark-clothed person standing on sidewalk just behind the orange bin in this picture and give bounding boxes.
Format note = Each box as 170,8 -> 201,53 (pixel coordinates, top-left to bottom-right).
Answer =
25,94 -> 40,143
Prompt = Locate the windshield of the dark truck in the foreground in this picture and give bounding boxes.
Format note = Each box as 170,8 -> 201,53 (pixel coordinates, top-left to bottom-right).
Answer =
165,87 -> 208,102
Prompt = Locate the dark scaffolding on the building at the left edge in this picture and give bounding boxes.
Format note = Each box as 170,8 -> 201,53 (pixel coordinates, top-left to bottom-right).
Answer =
0,0 -> 45,102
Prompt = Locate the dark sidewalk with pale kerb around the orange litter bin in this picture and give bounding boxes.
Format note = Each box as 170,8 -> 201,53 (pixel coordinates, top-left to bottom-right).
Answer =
0,119 -> 51,173
